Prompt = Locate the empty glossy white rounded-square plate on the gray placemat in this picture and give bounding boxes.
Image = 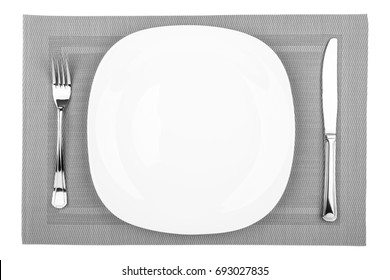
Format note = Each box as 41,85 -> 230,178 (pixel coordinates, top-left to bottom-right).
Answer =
88,26 -> 295,234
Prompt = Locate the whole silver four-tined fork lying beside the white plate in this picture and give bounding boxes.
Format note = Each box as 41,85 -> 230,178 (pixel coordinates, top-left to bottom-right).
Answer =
51,56 -> 72,208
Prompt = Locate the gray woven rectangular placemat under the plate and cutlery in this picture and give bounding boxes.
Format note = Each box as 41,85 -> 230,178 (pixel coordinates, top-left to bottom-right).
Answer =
22,15 -> 368,245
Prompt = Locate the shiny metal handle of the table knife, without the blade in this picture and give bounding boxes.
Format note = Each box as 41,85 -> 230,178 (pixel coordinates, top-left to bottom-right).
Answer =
322,134 -> 337,222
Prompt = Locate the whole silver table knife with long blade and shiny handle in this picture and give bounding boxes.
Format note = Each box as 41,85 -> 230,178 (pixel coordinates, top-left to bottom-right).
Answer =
321,38 -> 337,222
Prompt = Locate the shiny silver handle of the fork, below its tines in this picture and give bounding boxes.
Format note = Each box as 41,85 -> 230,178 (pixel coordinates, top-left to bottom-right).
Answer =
51,108 -> 68,208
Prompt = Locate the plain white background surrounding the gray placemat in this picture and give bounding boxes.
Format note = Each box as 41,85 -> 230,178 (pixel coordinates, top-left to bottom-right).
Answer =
0,0 -> 390,280
